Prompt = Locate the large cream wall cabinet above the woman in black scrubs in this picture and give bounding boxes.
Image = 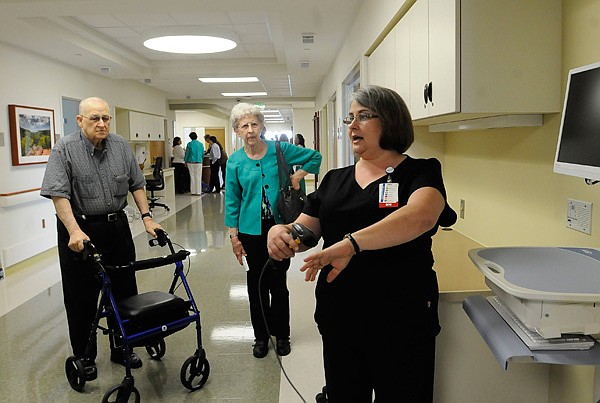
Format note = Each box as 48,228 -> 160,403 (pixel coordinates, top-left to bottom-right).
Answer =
368,0 -> 561,125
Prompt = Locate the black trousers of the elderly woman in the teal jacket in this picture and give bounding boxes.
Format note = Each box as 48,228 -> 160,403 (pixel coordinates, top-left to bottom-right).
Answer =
239,220 -> 290,340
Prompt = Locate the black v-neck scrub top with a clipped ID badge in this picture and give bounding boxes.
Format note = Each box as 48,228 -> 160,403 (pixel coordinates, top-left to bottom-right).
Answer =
304,156 -> 446,337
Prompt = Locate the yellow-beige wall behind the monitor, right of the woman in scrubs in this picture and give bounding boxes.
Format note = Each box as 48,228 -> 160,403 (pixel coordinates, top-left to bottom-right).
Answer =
436,0 -> 600,403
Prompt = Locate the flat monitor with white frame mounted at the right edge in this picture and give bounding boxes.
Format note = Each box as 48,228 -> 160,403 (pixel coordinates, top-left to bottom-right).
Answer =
554,62 -> 600,181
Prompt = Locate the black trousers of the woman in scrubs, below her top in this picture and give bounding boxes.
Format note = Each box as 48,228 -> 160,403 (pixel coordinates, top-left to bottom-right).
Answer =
321,332 -> 435,403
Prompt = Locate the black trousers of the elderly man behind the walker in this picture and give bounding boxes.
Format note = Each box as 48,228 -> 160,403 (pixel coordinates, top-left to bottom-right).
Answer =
57,213 -> 137,359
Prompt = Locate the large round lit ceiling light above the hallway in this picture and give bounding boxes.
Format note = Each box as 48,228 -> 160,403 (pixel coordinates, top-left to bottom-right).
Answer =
144,27 -> 237,54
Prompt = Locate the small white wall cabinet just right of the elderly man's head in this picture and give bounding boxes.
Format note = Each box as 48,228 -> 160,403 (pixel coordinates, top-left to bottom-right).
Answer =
116,109 -> 165,141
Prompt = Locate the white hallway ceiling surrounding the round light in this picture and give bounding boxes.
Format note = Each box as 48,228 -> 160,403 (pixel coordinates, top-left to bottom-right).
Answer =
0,0 -> 361,120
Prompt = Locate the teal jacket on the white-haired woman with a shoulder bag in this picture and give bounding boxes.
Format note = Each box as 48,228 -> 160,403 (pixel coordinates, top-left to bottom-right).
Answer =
225,140 -> 321,235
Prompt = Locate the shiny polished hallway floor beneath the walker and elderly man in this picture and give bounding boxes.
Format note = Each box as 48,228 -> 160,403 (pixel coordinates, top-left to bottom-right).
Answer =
0,194 -> 281,403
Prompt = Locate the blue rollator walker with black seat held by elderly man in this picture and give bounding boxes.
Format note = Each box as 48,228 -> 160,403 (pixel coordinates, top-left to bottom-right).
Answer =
65,230 -> 210,403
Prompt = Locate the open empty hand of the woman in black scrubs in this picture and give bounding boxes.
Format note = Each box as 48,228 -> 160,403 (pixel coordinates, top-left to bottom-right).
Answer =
300,239 -> 355,283
